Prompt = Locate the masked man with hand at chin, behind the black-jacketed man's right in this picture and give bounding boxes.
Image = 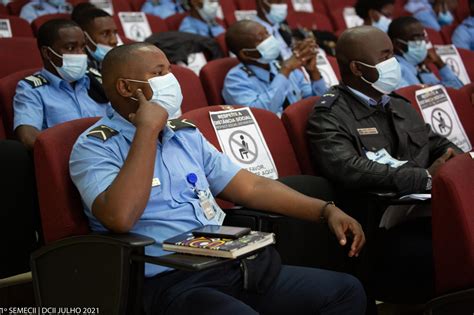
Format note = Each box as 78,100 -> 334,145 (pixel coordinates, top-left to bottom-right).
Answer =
388,16 -> 463,89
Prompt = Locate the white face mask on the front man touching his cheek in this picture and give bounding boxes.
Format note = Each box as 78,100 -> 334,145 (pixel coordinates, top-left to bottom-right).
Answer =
126,72 -> 183,119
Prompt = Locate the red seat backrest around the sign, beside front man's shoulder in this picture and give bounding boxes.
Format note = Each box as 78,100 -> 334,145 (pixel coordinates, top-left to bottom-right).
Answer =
182,106 -> 301,177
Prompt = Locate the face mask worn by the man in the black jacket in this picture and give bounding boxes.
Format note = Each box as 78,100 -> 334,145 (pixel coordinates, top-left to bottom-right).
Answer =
356,57 -> 402,94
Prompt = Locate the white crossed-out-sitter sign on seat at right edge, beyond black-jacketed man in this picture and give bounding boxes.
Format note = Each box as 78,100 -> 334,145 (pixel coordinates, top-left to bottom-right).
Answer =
416,85 -> 472,152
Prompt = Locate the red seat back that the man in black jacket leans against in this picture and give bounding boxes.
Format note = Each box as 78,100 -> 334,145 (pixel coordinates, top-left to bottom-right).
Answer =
281,96 -> 319,175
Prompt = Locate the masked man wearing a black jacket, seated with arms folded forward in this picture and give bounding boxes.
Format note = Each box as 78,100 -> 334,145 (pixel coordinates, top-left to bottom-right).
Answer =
307,26 -> 461,304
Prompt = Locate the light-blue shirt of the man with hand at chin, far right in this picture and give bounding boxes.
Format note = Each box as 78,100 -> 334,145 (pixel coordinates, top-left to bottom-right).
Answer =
395,55 -> 463,89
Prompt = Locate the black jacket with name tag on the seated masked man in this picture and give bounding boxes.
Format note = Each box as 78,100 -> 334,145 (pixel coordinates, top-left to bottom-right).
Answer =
307,85 -> 460,194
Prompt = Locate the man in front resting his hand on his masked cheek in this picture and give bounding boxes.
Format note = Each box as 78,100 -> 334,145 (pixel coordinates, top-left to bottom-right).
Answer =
70,43 -> 365,314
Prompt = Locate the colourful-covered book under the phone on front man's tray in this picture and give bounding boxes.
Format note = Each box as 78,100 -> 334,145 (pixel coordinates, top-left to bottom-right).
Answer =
163,230 -> 275,259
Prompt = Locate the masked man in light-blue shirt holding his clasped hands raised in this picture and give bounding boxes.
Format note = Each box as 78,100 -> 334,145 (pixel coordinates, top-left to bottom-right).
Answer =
222,20 -> 326,115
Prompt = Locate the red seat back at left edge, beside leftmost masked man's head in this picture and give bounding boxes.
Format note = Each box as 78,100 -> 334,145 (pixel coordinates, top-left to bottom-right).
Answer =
0,37 -> 43,78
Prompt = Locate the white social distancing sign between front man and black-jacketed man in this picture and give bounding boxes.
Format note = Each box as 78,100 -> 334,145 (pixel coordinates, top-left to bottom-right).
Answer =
209,107 -> 278,179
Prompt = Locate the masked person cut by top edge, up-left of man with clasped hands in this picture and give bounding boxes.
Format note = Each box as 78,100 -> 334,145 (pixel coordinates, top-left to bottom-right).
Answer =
179,0 -> 225,38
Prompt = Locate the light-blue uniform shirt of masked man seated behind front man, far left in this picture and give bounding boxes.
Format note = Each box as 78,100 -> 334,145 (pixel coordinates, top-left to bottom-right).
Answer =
13,69 -> 110,131
